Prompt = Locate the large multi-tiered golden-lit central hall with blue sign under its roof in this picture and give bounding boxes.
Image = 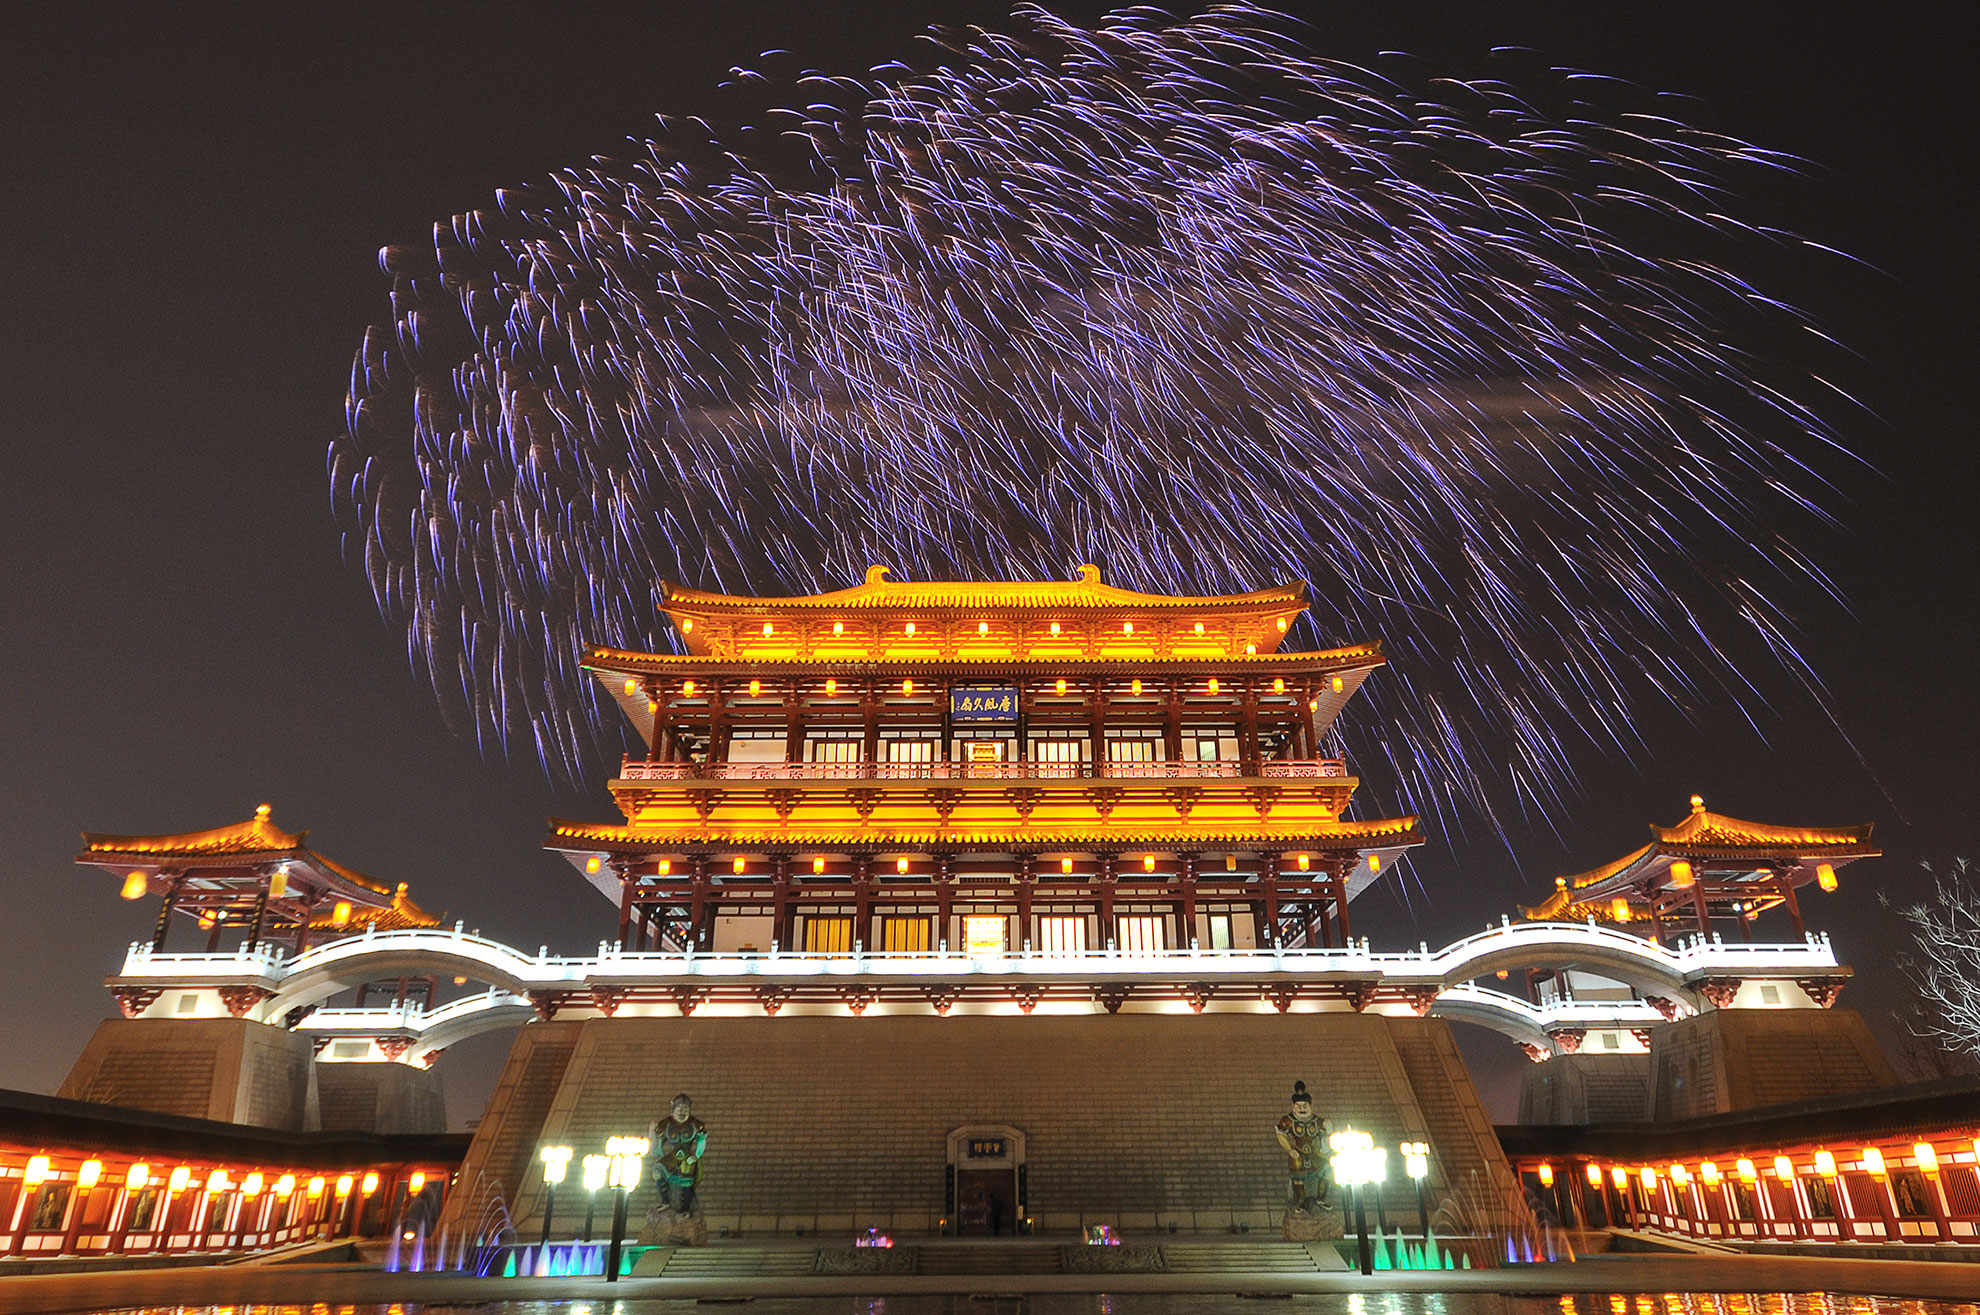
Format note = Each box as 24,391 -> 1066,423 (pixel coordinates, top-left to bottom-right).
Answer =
548,566 -> 1422,1012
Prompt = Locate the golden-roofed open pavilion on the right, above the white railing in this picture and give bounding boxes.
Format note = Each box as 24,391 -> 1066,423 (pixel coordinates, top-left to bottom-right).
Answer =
1521,794 -> 1879,941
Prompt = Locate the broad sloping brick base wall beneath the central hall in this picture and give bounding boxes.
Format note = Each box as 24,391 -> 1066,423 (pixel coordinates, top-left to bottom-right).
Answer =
457,1014 -> 1515,1238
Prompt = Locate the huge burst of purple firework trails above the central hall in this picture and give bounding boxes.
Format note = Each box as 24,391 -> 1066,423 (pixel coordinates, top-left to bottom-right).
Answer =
331,6 -> 1841,820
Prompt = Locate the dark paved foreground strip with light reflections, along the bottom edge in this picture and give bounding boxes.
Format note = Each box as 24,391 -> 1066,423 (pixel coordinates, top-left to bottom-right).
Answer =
0,1244 -> 1980,1315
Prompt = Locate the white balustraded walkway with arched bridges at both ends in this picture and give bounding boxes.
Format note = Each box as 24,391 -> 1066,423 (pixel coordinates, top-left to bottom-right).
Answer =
109,921 -> 1849,1062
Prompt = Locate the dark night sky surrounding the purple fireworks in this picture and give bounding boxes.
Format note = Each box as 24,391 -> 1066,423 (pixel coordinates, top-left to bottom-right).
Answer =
0,0 -> 1980,1123
